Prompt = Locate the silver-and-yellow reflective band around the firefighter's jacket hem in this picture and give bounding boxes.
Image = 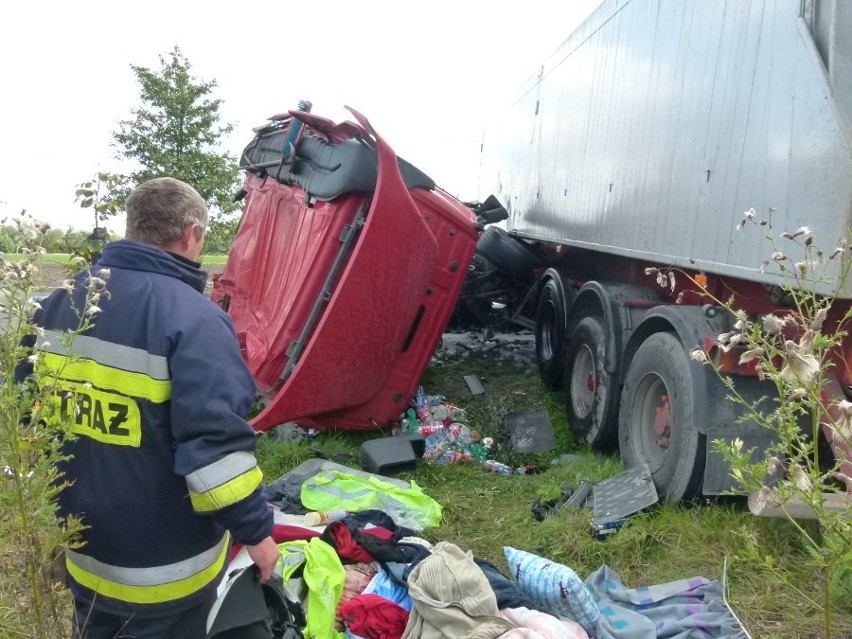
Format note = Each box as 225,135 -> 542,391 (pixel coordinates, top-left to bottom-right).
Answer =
65,534 -> 230,604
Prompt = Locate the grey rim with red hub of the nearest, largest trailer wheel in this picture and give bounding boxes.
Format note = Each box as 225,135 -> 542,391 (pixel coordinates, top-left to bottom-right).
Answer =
634,373 -> 674,474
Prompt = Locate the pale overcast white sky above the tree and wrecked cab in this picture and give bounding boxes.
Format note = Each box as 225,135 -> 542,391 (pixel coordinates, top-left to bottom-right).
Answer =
0,0 -> 600,234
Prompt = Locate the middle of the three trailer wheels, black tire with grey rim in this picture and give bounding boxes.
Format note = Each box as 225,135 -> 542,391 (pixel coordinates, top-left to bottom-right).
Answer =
564,317 -> 619,450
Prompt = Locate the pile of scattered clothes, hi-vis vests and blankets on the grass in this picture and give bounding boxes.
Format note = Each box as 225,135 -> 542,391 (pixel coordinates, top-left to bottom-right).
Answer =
208,462 -> 747,639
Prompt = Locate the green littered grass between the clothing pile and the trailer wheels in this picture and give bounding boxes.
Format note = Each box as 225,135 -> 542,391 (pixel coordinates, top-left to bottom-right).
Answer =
258,342 -> 852,639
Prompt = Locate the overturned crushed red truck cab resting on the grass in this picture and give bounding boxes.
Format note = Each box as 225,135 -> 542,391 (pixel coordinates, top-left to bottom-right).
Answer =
211,109 -> 479,431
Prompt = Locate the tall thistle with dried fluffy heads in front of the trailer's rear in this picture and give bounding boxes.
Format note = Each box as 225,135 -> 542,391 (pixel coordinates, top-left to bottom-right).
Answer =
646,209 -> 852,637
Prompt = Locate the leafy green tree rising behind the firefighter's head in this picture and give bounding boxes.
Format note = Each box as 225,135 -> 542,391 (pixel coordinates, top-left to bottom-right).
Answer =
109,47 -> 240,231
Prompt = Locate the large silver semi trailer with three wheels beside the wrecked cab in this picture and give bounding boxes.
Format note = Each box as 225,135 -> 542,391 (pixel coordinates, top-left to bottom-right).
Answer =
480,0 -> 852,498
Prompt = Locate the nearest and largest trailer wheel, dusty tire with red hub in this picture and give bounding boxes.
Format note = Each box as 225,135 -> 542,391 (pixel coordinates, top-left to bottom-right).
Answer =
618,333 -> 706,500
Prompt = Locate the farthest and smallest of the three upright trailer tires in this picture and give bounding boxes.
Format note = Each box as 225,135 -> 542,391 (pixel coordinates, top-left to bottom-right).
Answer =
535,273 -> 573,388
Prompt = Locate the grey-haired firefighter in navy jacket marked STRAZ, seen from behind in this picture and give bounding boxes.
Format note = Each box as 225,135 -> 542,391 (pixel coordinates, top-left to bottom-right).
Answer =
28,178 -> 279,639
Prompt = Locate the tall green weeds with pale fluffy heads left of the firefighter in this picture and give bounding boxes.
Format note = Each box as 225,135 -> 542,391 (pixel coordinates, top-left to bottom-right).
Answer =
0,222 -> 107,638
